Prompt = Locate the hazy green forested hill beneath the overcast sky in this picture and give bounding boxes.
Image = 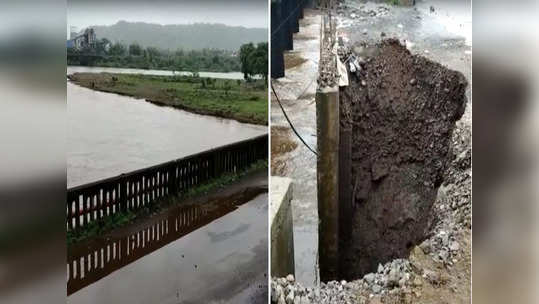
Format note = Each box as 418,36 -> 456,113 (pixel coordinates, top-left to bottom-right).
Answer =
87,21 -> 268,50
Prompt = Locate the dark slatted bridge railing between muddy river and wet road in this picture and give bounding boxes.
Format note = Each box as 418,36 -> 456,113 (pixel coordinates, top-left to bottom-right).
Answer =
66,134 -> 268,231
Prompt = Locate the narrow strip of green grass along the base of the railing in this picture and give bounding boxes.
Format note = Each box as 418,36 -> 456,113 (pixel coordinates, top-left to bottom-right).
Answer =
67,160 -> 268,246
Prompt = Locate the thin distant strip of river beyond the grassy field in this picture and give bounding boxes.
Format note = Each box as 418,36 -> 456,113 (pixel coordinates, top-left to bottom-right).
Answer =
67,66 -> 243,79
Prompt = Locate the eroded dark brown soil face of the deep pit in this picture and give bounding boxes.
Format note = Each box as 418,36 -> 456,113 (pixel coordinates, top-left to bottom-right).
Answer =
340,39 -> 467,279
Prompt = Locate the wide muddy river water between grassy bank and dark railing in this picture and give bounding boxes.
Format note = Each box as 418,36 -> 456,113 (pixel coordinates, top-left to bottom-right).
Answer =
67,82 -> 267,187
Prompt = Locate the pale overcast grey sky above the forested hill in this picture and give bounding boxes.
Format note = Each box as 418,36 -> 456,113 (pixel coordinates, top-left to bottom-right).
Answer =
67,0 -> 268,33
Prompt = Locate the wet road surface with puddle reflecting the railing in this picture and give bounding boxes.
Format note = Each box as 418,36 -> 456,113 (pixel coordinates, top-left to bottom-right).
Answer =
67,188 -> 268,304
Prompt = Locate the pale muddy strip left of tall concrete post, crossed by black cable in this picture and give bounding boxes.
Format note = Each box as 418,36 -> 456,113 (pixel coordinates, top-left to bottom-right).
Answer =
271,10 -> 321,286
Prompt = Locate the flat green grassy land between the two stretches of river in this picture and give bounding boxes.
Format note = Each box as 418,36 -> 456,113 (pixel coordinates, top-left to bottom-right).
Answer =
68,73 -> 268,125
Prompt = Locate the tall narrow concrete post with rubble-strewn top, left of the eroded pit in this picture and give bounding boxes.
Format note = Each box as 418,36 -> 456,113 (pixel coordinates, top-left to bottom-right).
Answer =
316,11 -> 340,282
